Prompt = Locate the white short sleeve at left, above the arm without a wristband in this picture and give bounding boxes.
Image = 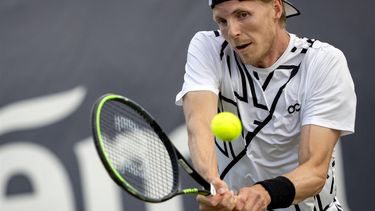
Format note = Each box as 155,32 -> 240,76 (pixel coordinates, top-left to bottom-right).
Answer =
176,32 -> 220,105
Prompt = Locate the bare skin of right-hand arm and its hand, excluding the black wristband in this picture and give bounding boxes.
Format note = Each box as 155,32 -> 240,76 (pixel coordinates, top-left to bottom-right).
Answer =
236,125 -> 340,210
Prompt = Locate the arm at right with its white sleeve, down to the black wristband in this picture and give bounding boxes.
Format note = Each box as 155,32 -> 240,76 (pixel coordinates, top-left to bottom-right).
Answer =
284,46 -> 356,203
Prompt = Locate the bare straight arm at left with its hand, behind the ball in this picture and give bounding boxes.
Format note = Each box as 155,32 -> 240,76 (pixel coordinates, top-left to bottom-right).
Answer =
183,91 -> 236,211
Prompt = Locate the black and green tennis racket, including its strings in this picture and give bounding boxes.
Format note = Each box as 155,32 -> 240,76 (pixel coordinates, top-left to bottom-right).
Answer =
92,94 -> 215,202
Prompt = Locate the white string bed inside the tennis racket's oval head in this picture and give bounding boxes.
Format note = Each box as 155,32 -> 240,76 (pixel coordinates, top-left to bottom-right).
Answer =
100,101 -> 177,200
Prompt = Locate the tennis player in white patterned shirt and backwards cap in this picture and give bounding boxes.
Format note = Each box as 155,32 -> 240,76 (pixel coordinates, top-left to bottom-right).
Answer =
176,0 -> 356,211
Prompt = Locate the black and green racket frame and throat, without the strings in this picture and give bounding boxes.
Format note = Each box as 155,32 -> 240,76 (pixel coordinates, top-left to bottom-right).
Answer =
91,94 -> 216,203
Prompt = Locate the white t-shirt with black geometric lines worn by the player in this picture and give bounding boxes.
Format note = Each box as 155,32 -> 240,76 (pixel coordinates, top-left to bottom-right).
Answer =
176,31 -> 356,211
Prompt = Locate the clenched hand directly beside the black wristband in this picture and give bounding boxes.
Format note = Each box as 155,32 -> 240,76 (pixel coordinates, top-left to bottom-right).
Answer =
234,184 -> 271,211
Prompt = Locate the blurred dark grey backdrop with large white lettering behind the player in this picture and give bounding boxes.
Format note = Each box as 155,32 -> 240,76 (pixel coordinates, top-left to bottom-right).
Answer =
0,0 -> 375,211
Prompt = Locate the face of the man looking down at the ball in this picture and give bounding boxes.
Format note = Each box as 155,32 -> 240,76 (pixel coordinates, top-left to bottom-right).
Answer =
213,0 -> 280,67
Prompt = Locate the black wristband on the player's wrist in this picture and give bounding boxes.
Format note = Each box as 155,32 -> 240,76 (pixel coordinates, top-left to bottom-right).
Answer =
256,176 -> 296,209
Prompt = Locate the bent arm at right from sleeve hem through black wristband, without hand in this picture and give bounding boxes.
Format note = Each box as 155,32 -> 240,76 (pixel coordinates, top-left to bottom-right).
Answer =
250,125 -> 340,209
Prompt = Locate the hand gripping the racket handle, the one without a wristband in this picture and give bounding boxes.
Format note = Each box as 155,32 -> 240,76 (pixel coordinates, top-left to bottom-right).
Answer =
197,178 -> 236,211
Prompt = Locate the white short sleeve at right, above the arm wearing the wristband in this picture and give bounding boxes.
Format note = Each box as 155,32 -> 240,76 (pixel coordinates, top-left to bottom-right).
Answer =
301,46 -> 356,136
